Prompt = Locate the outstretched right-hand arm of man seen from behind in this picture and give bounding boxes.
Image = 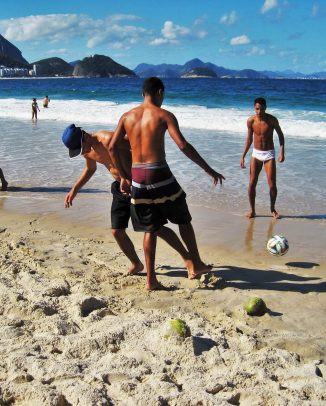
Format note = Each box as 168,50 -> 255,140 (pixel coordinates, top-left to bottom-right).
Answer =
167,112 -> 225,185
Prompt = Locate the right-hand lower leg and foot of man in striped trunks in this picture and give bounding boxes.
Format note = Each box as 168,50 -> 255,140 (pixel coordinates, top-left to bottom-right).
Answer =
179,223 -> 212,279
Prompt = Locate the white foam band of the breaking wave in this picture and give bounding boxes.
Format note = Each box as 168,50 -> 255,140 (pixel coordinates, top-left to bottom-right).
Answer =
0,99 -> 326,138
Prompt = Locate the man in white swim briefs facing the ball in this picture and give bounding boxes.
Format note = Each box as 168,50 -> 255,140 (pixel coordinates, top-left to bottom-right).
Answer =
240,97 -> 284,219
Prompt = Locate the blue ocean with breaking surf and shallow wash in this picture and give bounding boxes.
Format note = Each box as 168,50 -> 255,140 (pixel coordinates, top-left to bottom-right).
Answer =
0,78 -> 326,227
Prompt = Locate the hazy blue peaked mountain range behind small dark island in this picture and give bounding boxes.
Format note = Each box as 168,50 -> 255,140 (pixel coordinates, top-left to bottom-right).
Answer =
134,58 -> 267,79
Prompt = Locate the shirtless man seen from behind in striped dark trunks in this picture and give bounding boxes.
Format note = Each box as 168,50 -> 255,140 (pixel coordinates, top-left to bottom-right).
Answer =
109,77 -> 224,290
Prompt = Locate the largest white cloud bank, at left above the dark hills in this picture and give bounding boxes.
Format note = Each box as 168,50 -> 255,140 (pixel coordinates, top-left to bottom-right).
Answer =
0,14 -> 148,48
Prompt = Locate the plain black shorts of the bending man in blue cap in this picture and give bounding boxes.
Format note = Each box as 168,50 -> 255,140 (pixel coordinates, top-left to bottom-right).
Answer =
111,181 -> 130,229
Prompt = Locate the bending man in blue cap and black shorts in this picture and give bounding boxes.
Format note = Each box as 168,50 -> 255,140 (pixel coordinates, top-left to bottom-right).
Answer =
62,124 -> 190,274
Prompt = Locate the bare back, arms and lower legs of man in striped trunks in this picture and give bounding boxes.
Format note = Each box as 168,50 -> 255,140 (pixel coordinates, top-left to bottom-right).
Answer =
109,85 -> 224,290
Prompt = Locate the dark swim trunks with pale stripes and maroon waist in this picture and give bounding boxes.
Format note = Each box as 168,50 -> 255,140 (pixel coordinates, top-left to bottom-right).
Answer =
131,161 -> 191,232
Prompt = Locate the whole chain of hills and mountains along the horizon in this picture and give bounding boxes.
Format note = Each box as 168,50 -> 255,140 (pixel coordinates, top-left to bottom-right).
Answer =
0,35 -> 326,79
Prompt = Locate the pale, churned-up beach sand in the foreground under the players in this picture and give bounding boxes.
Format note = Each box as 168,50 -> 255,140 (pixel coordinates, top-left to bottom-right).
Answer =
0,205 -> 326,406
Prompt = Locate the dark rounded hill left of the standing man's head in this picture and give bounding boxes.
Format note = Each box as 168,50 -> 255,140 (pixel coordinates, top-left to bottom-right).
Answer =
73,55 -> 136,77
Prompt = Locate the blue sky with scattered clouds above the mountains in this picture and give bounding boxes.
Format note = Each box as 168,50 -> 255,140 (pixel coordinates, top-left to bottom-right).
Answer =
0,0 -> 326,73
